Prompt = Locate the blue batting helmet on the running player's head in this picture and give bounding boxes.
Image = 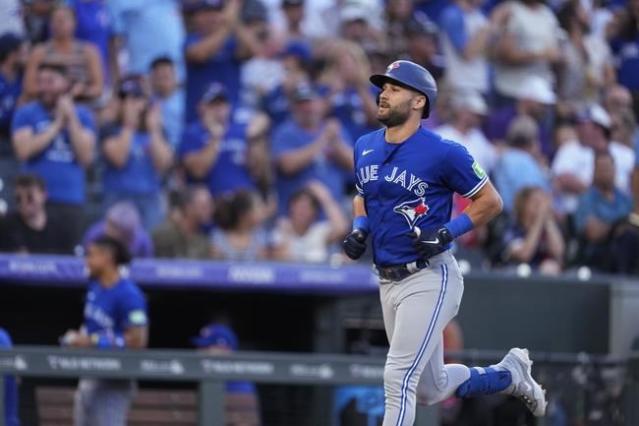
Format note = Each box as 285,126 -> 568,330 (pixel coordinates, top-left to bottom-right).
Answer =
370,61 -> 437,118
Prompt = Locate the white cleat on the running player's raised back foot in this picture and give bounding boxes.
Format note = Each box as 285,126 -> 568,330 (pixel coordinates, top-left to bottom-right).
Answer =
497,348 -> 548,417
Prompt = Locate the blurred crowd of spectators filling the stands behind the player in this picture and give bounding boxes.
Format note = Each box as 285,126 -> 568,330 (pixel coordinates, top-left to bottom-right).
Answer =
0,0 -> 639,274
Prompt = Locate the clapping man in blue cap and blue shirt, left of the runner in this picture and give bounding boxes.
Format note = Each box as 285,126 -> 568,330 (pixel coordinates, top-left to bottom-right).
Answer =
179,83 -> 268,197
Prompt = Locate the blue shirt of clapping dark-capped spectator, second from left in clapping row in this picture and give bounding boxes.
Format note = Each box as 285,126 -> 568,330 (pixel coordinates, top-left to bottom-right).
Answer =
101,126 -> 160,195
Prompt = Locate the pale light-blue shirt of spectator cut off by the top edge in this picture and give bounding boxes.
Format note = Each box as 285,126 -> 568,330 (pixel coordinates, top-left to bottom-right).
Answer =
107,0 -> 184,80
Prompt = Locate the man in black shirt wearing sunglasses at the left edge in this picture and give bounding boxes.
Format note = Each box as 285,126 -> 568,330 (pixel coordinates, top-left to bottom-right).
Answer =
0,174 -> 77,254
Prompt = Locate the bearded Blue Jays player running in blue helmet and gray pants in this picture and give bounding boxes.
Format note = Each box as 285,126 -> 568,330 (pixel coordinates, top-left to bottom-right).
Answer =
343,61 -> 546,426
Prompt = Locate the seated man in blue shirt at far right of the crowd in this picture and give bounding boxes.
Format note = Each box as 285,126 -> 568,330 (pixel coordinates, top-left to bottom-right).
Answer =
575,152 -> 632,269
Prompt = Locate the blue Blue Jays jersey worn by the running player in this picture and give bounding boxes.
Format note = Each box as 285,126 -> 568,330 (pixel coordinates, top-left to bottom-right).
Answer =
355,127 -> 488,266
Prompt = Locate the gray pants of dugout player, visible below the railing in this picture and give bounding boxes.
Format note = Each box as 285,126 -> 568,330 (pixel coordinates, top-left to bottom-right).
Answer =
73,379 -> 135,426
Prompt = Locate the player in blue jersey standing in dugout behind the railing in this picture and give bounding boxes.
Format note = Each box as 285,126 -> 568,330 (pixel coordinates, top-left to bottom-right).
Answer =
61,236 -> 148,426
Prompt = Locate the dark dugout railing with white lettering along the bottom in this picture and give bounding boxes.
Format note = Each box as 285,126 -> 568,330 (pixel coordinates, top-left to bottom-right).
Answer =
0,346 -> 639,426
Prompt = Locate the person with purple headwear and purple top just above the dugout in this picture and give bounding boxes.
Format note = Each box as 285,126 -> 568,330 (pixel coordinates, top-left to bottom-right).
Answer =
82,201 -> 153,257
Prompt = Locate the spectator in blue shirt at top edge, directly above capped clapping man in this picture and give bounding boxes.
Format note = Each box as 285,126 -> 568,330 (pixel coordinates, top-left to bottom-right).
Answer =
184,0 -> 260,123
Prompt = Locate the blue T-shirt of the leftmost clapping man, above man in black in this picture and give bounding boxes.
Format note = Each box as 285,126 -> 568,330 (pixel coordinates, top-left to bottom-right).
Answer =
12,102 -> 94,204
